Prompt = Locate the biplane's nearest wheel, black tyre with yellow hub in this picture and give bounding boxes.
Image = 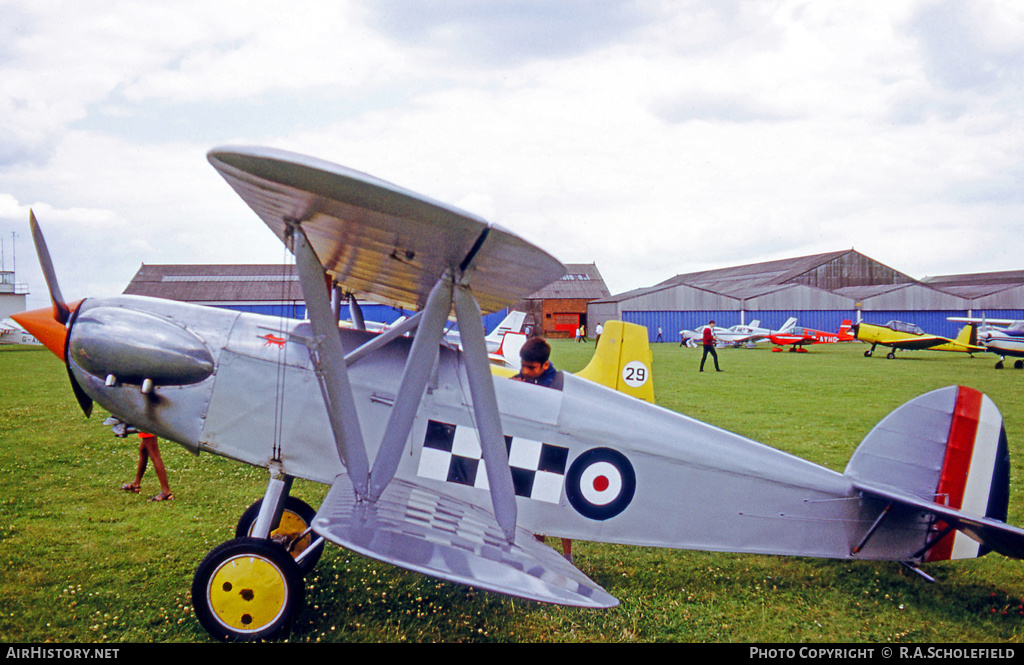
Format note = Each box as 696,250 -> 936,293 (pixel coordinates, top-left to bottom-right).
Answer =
191,538 -> 305,641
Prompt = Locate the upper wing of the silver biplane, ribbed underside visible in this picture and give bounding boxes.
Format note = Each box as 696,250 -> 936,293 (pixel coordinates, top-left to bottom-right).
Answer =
207,148 -> 565,313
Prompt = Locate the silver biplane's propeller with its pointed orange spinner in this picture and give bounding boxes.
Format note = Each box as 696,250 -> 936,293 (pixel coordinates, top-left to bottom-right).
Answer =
11,210 -> 92,417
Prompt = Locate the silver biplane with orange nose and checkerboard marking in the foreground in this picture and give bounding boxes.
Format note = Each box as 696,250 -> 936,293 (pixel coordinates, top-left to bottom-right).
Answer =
18,148 -> 1024,639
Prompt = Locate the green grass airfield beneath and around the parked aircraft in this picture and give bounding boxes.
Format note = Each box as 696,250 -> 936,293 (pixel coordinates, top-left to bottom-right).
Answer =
0,341 -> 1024,642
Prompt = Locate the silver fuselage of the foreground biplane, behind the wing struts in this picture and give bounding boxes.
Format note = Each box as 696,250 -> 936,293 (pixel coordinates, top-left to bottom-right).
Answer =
69,296 -> 927,559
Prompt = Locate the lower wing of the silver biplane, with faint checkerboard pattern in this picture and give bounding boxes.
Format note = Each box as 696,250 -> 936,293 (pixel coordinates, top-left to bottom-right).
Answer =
313,474 -> 618,608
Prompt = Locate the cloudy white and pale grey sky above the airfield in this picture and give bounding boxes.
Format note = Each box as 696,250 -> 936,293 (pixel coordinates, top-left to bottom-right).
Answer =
0,0 -> 1024,306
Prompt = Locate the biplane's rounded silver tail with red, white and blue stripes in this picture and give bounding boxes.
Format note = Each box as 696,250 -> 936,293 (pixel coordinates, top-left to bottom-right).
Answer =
845,386 -> 1024,560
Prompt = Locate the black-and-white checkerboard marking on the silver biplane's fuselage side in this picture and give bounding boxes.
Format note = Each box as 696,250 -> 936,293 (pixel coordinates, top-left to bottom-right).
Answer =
418,420 -> 569,503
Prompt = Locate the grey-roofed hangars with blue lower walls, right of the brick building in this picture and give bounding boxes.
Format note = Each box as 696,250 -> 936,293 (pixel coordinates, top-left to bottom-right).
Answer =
587,249 -> 1024,341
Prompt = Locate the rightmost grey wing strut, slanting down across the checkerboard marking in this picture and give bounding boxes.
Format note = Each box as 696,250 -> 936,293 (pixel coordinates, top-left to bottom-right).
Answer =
455,285 -> 516,542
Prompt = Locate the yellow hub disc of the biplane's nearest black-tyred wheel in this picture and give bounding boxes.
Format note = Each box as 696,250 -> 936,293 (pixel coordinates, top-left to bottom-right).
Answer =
207,554 -> 288,632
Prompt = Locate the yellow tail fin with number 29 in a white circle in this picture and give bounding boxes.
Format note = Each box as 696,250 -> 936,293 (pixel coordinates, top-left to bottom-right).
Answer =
577,321 -> 654,402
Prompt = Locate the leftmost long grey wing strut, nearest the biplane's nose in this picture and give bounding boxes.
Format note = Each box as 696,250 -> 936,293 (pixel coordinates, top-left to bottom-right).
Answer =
289,223 -> 370,498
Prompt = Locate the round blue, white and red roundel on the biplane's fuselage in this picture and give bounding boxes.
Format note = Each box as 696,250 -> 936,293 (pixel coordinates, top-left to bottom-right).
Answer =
565,448 -> 636,519
